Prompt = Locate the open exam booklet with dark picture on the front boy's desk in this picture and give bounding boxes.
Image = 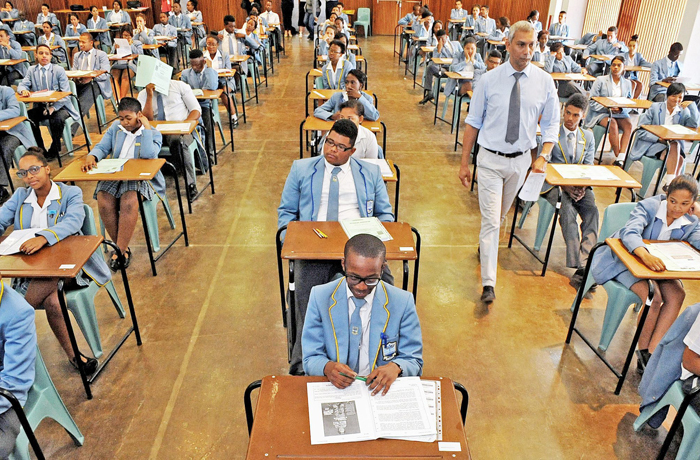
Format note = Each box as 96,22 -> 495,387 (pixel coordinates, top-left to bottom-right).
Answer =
307,377 -> 442,445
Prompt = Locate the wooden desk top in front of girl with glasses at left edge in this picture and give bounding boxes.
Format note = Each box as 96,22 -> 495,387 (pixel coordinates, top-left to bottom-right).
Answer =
0,235 -> 103,278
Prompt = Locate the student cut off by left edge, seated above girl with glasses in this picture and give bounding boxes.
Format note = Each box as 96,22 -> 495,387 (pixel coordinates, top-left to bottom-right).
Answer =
0,85 -> 36,204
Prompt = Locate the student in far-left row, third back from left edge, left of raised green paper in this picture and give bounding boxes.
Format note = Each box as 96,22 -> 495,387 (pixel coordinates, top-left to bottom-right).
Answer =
73,32 -> 112,113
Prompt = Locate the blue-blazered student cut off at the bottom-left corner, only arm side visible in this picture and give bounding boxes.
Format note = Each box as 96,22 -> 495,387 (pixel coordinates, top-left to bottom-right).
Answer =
0,272 -> 36,458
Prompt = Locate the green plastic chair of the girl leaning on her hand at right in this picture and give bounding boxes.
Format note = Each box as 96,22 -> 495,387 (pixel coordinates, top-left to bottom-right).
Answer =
571,203 -> 646,351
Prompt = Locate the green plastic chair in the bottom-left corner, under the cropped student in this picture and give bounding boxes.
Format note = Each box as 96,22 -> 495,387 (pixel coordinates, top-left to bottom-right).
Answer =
10,347 -> 85,460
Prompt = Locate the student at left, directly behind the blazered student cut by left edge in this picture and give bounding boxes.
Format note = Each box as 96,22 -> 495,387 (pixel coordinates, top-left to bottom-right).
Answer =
17,45 -> 80,162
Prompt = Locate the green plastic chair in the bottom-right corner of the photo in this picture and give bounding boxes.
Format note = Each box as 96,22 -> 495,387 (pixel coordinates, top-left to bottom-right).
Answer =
633,380 -> 700,460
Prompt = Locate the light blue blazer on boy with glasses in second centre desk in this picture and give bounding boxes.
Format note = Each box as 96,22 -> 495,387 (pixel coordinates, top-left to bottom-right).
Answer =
277,155 -> 394,228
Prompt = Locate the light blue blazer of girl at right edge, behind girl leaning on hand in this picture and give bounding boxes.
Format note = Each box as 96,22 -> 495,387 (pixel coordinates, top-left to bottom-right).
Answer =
630,101 -> 700,161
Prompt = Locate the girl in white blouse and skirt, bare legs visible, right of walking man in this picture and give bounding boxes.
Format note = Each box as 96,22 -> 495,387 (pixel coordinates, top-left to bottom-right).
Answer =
584,56 -> 632,166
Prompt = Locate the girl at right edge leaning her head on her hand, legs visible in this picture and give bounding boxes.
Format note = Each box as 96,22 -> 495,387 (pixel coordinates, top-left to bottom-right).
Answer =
591,175 -> 700,370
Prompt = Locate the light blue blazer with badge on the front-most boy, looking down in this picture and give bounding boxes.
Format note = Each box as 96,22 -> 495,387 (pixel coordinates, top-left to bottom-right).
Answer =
301,278 -> 423,376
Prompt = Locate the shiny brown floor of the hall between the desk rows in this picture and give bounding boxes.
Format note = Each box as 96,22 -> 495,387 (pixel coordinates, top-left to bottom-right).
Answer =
24,37 -> 700,459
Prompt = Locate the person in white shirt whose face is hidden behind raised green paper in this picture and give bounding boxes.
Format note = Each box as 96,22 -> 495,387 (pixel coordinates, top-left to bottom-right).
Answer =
138,80 -> 202,200
